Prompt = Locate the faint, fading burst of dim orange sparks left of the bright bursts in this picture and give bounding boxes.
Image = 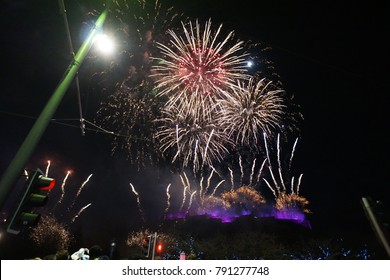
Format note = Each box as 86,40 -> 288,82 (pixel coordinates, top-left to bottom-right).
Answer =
98,85 -> 162,166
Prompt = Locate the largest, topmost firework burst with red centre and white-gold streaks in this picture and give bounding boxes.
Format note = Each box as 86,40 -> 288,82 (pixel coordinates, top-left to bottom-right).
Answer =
152,20 -> 248,111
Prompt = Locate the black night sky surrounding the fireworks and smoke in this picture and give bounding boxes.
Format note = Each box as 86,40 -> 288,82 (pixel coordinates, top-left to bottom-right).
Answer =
0,0 -> 390,258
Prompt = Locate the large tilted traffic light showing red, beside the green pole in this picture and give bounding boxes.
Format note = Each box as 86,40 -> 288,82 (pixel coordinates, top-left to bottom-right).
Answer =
7,169 -> 55,234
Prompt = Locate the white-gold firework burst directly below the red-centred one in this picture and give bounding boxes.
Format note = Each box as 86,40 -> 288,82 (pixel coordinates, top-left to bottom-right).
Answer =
155,103 -> 230,173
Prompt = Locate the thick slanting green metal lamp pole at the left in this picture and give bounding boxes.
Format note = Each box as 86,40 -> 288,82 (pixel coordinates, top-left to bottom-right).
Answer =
0,10 -> 108,208
